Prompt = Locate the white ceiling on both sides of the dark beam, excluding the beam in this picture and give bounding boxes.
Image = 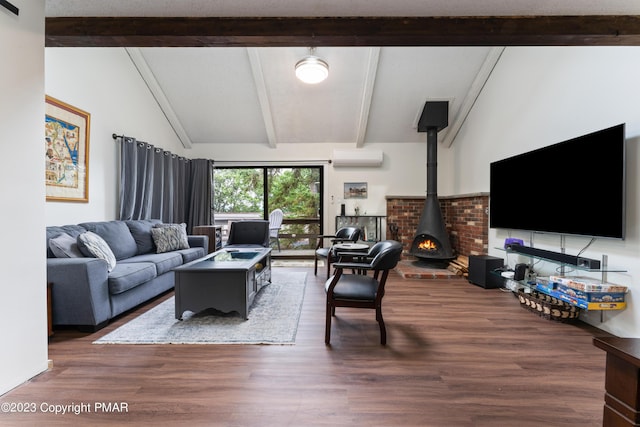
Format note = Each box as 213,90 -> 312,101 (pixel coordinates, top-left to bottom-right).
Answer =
46,0 -> 640,148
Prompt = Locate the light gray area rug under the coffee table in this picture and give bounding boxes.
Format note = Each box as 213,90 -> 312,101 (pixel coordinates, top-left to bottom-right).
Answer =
94,269 -> 307,344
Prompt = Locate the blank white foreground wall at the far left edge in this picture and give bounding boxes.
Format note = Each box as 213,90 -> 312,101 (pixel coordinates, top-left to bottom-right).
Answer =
0,0 -> 47,394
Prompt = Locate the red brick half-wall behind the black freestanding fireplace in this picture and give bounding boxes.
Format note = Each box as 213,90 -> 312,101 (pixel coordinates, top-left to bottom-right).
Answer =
387,194 -> 489,258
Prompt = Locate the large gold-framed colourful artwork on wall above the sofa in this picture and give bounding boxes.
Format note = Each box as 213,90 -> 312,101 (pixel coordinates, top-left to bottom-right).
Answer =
44,96 -> 91,203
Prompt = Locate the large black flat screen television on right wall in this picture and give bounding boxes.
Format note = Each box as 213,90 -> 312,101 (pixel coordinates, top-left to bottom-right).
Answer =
489,124 -> 625,239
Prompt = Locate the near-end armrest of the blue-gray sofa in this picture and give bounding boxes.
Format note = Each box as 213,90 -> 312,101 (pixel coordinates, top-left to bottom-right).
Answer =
47,258 -> 111,326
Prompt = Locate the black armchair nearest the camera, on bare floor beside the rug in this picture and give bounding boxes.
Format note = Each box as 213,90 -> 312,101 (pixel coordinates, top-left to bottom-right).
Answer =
324,240 -> 402,345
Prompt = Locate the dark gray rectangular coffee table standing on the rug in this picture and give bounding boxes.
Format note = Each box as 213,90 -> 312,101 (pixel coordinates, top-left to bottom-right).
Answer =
174,248 -> 271,320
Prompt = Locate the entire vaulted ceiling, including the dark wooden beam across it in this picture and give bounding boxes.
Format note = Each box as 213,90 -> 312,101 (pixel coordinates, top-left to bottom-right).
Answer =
46,0 -> 640,148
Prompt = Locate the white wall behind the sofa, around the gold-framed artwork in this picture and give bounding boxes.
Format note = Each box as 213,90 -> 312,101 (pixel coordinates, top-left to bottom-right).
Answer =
45,48 -> 184,225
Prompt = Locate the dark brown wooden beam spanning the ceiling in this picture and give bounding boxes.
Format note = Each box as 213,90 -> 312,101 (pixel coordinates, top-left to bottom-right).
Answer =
45,15 -> 640,47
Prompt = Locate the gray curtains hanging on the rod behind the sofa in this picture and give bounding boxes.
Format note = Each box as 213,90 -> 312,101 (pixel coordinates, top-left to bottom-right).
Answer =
119,137 -> 211,232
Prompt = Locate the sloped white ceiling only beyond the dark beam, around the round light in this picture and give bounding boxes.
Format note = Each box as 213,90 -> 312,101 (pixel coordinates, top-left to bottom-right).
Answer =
129,47 -> 495,147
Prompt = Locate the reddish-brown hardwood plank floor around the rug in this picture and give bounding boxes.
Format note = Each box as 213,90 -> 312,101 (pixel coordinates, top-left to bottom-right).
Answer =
0,267 -> 607,427
